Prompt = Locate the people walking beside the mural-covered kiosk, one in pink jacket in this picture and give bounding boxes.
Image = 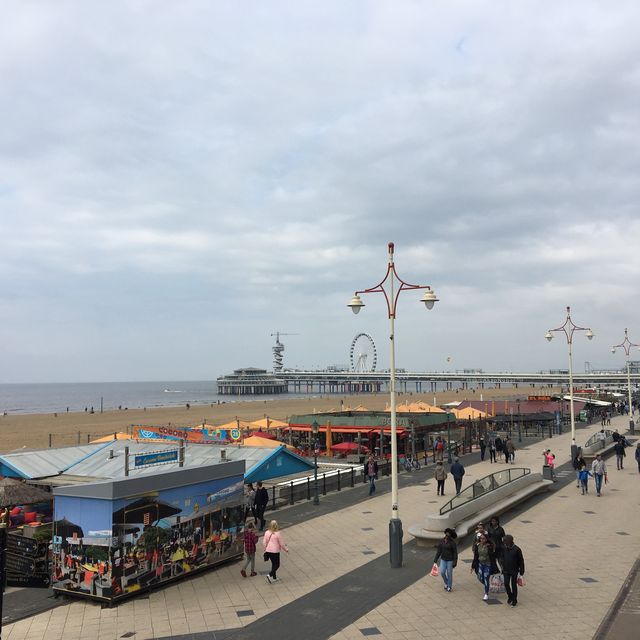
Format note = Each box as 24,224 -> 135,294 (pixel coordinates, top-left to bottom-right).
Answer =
240,481 -> 289,584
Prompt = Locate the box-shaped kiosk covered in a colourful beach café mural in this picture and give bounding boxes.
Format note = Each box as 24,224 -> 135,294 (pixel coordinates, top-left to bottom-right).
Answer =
52,460 -> 245,603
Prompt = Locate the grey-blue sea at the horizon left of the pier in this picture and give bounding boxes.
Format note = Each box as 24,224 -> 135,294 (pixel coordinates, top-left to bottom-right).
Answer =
0,380 -> 318,414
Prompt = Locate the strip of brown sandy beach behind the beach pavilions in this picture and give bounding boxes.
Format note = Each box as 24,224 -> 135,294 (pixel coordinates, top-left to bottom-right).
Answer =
0,387 -> 556,453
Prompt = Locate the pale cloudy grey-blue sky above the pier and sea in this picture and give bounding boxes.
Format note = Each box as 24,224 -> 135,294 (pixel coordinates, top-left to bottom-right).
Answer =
0,0 -> 640,383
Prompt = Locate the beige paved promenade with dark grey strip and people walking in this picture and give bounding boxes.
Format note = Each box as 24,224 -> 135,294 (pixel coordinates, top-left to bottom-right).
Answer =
3,417 -> 640,640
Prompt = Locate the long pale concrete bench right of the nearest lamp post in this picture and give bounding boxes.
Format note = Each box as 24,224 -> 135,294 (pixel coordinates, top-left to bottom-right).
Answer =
409,473 -> 553,546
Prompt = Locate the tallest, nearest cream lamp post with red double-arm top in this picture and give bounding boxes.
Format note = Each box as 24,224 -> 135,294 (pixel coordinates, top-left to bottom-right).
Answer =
348,242 -> 438,568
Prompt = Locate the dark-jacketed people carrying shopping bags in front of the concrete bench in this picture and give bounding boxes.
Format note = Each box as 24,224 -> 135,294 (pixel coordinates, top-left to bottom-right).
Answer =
432,516 -> 524,607
